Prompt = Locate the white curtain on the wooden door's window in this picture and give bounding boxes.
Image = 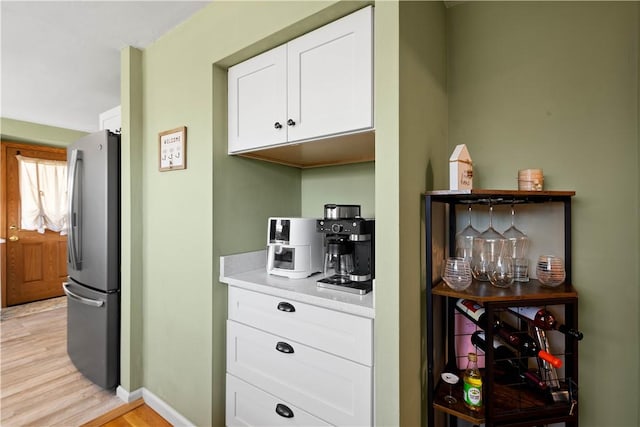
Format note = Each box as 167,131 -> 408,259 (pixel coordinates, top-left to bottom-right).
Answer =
16,156 -> 68,234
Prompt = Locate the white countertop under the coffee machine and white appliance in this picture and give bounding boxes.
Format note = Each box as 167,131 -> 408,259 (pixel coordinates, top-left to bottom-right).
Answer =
220,250 -> 375,319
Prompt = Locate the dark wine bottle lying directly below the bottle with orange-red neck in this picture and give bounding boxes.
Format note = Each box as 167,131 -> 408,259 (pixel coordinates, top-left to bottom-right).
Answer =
471,331 -> 548,391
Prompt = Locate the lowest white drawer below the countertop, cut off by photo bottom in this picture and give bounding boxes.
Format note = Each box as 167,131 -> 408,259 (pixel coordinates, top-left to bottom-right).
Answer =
226,374 -> 331,427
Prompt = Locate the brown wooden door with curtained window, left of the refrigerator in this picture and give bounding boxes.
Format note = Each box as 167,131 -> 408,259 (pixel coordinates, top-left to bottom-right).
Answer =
1,142 -> 67,307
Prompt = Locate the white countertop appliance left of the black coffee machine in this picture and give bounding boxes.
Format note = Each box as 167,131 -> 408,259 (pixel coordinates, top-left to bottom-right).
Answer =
267,217 -> 323,279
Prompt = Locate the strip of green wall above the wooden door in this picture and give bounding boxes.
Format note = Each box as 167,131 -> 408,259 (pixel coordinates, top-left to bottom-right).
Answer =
0,117 -> 86,147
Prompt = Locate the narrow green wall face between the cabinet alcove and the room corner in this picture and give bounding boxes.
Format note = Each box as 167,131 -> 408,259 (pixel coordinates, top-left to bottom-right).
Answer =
396,1 -> 449,426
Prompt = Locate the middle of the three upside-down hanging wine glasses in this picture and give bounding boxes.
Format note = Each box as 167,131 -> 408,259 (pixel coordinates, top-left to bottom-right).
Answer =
471,205 -> 507,282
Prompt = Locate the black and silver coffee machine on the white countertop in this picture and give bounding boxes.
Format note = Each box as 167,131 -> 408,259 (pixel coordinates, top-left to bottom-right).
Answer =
316,204 -> 375,295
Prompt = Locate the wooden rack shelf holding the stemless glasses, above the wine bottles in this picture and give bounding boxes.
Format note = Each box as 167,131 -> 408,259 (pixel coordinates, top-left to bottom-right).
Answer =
431,279 -> 578,303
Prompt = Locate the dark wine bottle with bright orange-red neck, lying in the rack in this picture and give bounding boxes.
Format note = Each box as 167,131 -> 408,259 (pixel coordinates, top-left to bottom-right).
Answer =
456,298 -> 562,368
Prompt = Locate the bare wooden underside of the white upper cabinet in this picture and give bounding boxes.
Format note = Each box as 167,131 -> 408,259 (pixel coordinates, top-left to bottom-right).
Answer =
237,130 -> 376,169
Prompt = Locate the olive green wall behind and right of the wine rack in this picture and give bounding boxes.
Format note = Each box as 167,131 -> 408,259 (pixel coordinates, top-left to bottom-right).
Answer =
447,2 -> 640,426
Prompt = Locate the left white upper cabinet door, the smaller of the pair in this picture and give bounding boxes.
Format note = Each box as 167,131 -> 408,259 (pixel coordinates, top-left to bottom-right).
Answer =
228,46 -> 287,153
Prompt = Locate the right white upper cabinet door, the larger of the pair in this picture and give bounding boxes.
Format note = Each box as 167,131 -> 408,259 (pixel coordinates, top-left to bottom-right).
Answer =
287,7 -> 373,141
